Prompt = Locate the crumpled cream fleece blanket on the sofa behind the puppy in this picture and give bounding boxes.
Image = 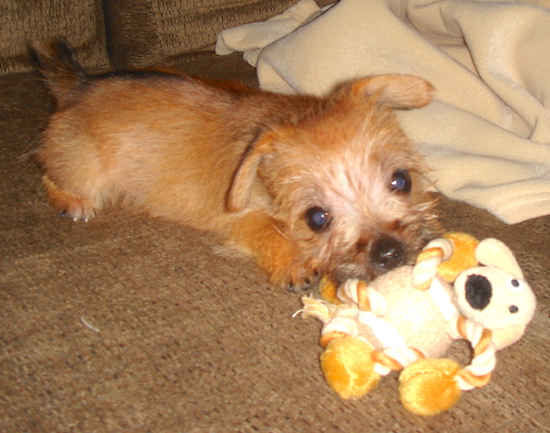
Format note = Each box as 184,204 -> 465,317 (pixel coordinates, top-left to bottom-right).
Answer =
216,0 -> 550,224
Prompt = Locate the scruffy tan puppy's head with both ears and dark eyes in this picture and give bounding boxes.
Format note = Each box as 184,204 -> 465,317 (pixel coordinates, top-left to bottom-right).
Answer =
229,75 -> 438,280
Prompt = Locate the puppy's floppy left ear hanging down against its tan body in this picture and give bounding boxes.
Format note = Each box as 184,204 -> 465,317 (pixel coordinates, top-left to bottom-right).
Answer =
226,131 -> 273,212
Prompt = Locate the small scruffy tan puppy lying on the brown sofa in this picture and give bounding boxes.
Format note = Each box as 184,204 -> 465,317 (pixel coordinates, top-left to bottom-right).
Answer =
36,44 -> 439,289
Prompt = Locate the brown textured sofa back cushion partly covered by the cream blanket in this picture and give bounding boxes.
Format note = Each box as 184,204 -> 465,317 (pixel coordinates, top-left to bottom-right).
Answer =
105,0 -> 334,69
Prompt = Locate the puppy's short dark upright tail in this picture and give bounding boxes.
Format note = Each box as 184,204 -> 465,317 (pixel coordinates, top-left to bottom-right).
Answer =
31,41 -> 87,107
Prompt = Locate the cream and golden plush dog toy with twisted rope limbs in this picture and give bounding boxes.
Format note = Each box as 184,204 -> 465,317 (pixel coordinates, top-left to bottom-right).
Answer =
300,233 -> 536,416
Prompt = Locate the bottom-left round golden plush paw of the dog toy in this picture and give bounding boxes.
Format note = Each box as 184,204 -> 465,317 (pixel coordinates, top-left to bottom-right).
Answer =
321,337 -> 380,399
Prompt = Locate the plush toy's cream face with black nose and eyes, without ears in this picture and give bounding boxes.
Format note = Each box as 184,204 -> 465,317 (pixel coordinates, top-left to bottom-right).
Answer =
455,266 -> 536,329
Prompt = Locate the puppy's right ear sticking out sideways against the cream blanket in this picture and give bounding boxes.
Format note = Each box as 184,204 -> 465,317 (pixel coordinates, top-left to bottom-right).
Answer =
350,75 -> 435,109
